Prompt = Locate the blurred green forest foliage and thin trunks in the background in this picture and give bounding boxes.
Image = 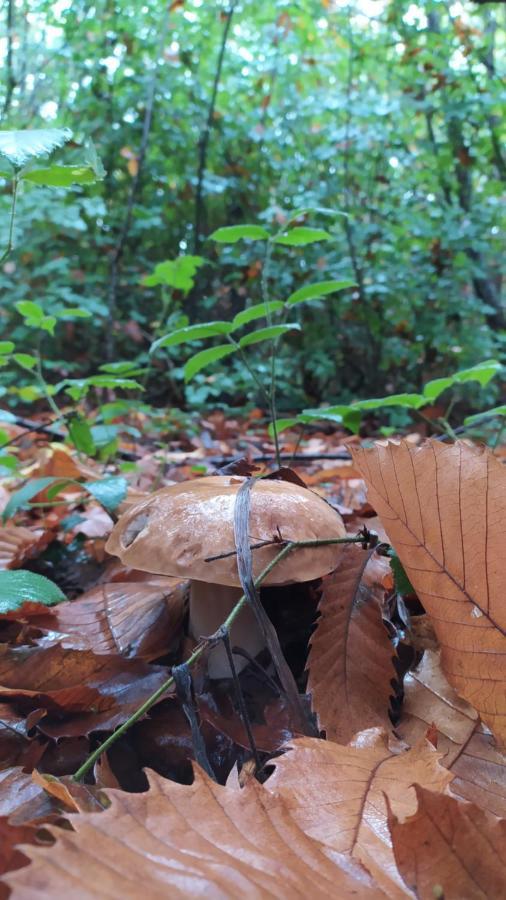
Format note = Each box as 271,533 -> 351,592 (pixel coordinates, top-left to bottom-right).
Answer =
0,0 -> 506,411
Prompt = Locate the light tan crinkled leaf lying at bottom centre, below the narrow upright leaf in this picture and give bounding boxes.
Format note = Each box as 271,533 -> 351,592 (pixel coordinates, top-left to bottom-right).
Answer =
266,728 -> 452,898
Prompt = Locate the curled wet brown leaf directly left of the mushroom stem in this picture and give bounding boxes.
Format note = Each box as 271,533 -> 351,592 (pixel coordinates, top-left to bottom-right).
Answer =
30,575 -> 188,660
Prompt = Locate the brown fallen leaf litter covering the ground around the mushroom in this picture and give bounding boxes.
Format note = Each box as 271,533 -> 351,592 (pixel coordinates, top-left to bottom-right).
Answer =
0,417 -> 506,898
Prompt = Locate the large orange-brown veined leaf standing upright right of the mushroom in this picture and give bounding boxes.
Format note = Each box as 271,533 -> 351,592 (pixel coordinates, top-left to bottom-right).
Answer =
353,441 -> 506,744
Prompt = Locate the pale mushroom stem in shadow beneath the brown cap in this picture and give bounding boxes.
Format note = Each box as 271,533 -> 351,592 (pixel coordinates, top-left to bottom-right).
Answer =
189,581 -> 265,678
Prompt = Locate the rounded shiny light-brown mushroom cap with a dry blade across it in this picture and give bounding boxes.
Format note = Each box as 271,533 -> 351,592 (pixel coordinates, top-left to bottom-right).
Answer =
106,475 -> 346,587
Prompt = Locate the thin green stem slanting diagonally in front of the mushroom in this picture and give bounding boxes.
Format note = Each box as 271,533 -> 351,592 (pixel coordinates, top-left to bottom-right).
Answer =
72,538 -> 368,781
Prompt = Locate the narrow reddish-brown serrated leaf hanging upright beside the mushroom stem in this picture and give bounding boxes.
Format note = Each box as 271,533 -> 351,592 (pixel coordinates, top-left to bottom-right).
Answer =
306,545 -> 396,743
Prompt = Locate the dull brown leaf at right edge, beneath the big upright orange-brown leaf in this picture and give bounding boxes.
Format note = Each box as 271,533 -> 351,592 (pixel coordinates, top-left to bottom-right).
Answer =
396,651 -> 506,817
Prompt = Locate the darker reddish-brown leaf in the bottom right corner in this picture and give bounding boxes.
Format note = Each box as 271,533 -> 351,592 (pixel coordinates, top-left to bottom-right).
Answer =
390,785 -> 506,900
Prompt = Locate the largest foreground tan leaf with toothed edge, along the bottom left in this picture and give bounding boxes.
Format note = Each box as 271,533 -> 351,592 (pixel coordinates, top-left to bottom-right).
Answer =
6,769 -> 385,900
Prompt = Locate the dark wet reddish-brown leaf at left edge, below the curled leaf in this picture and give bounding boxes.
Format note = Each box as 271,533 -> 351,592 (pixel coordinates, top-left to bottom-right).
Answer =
0,644 -> 167,738
